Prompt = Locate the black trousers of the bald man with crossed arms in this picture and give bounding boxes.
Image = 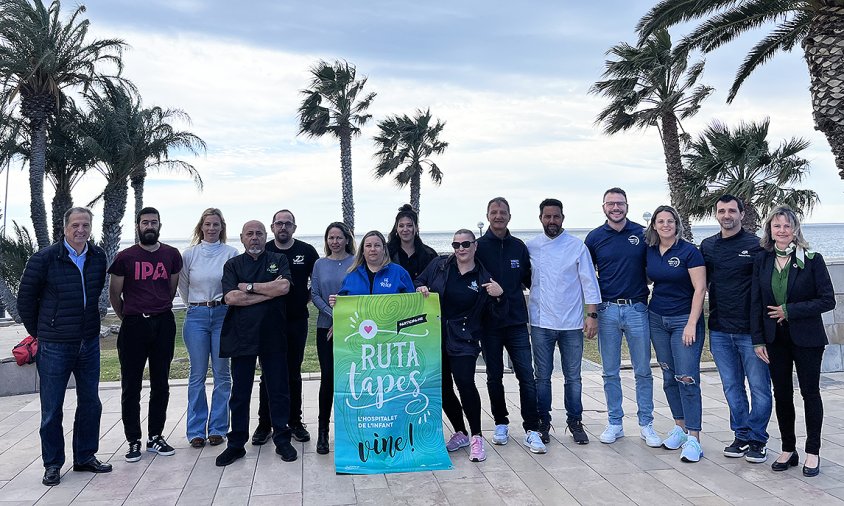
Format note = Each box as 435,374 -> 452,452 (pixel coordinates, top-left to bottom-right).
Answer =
228,351 -> 290,448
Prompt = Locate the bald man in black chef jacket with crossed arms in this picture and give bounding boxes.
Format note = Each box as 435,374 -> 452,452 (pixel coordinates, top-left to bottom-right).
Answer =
216,220 -> 297,467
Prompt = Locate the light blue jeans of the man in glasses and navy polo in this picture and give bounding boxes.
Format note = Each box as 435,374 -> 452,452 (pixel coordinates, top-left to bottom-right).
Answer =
598,302 -> 654,427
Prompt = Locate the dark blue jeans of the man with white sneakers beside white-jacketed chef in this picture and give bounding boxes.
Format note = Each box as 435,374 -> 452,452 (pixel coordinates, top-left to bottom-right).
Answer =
481,324 -> 539,430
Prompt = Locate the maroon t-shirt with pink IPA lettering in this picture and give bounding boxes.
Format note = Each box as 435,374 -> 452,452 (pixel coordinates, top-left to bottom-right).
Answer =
108,243 -> 182,315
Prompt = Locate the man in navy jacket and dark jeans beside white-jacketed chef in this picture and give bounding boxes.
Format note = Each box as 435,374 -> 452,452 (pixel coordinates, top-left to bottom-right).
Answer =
476,197 -> 546,453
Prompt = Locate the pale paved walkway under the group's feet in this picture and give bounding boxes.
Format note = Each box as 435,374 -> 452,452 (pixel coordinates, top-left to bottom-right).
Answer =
0,370 -> 844,506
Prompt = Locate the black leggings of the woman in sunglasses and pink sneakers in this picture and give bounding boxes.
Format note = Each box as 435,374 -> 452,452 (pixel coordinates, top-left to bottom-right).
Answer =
443,351 -> 481,436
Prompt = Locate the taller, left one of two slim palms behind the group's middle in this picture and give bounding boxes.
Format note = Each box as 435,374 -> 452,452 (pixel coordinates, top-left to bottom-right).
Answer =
298,60 -> 375,230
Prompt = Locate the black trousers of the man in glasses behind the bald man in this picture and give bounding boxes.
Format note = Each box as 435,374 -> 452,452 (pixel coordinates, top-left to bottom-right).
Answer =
258,318 -> 308,429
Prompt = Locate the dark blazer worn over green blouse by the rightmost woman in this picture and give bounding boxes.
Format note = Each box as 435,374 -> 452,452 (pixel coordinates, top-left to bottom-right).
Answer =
750,251 -> 835,347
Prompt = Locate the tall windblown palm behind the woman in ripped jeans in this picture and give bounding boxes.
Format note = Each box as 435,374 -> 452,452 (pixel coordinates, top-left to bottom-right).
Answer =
590,30 -> 713,240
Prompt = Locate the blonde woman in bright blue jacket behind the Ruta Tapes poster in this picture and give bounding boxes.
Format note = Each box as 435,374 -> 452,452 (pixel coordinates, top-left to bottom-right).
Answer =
336,230 -> 414,296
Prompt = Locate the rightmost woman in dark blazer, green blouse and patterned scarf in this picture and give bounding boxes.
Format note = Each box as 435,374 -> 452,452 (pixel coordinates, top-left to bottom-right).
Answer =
750,206 -> 835,476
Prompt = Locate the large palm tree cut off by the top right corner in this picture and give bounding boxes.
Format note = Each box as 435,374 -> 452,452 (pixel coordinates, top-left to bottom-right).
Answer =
636,0 -> 844,179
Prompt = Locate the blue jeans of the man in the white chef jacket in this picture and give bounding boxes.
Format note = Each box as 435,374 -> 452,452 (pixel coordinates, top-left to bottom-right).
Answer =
530,325 -> 583,423
